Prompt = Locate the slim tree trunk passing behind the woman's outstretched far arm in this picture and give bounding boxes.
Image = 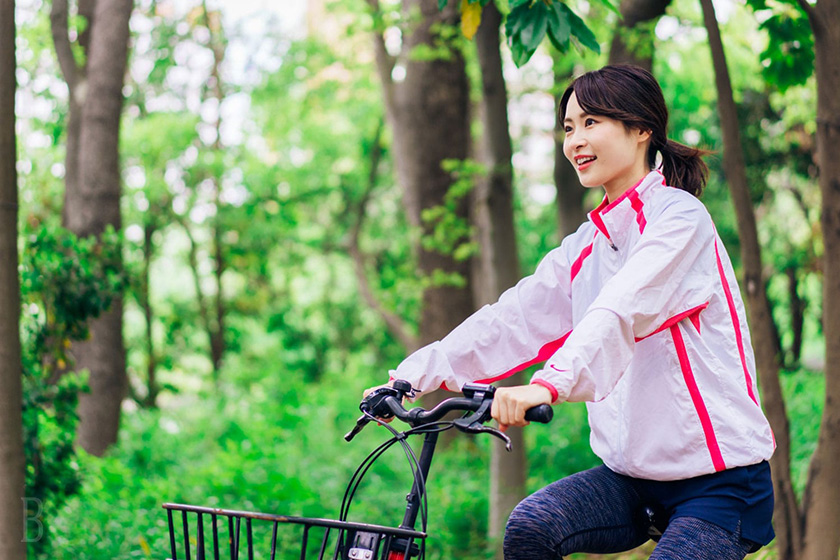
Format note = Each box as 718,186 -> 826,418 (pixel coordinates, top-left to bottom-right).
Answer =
480,2 -> 528,560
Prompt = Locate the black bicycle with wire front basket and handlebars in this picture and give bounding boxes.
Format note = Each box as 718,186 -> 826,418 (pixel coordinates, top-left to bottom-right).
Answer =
163,380 -> 553,560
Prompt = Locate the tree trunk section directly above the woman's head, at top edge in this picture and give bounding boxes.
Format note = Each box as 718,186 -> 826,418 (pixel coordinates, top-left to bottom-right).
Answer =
609,0 -> 671,72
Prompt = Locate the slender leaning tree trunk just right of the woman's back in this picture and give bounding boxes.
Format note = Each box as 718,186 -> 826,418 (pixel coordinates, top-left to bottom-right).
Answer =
700,0 -> 802,559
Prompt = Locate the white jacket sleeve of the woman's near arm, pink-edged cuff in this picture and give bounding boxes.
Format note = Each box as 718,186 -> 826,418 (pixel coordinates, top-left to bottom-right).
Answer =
531,199 -> 715,401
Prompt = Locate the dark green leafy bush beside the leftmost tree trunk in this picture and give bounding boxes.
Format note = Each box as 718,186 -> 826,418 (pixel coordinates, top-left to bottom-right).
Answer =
21,225 -> 123,552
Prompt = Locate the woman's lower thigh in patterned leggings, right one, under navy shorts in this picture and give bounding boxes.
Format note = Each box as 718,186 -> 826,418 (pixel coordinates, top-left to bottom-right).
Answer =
650,517 -> 752,560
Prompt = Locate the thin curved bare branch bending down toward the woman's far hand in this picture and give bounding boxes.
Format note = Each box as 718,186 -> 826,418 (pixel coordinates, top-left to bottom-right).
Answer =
348,120 -> 420,351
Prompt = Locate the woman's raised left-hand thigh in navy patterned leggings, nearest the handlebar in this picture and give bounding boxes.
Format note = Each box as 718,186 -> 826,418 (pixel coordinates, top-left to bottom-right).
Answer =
504,467 -> 647,560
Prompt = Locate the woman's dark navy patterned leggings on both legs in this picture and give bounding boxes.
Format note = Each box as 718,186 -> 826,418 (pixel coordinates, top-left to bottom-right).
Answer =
504,467 -> 752,560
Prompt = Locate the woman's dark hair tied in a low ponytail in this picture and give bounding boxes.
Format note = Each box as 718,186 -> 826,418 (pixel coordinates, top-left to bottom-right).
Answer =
560,64 -> 709,196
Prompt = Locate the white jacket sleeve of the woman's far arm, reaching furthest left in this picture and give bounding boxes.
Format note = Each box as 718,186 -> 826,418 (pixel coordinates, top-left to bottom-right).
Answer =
390,243 -> 572,391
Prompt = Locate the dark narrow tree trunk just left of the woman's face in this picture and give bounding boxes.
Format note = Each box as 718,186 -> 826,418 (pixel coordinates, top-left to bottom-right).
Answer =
554,63 -> 586,239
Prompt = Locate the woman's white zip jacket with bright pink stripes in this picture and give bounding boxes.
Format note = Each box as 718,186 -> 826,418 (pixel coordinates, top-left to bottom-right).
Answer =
391,171 -> 775,480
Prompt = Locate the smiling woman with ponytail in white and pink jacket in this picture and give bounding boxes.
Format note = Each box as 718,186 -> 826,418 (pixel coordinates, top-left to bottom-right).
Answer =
368,66 -> 775,560
